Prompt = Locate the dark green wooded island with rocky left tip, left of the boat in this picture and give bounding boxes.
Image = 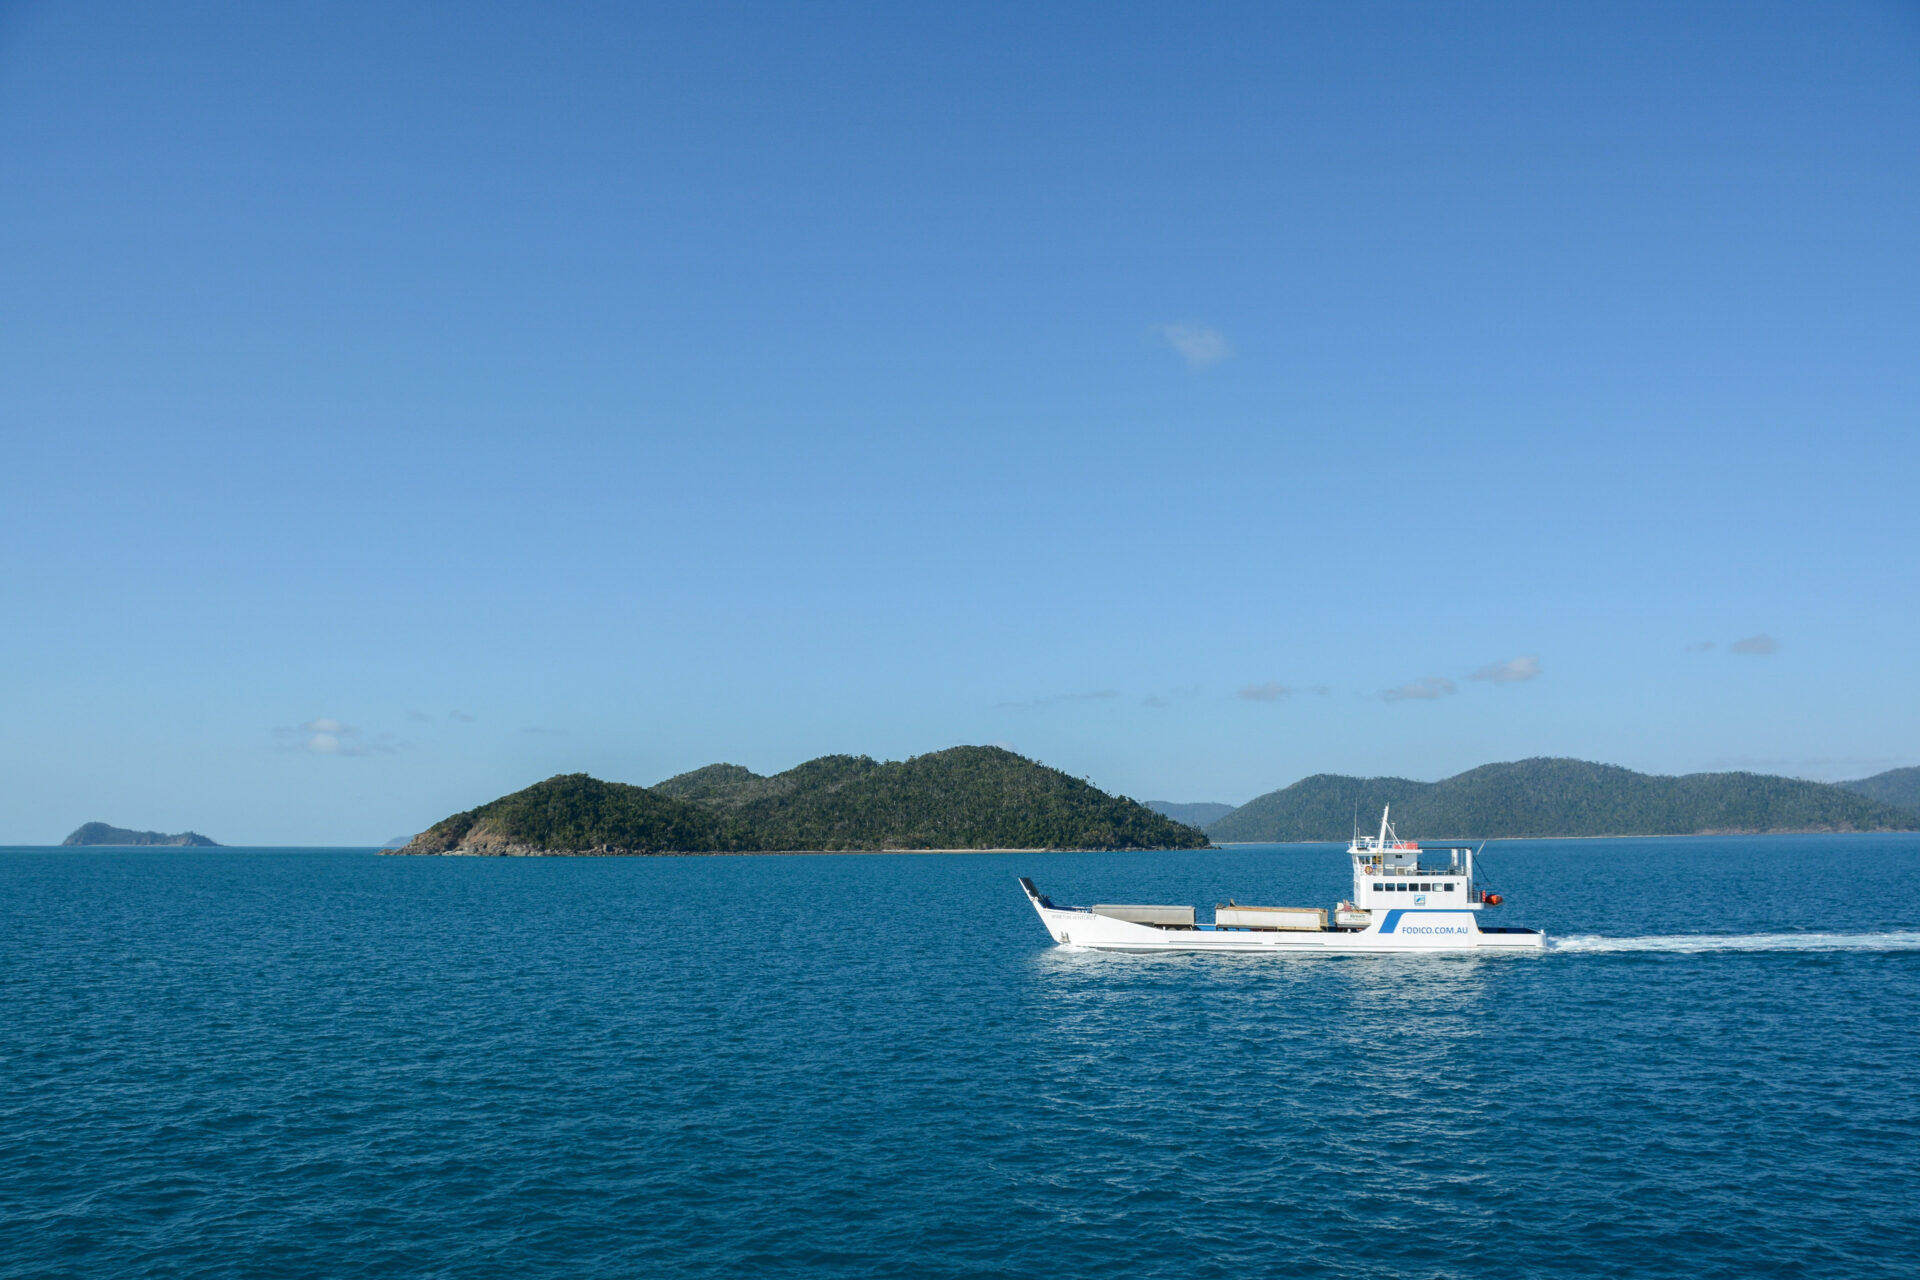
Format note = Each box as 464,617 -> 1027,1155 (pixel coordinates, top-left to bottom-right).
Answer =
394,747 -> 1208,854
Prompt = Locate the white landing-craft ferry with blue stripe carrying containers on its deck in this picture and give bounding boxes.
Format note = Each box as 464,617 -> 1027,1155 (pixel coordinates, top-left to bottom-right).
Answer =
1020,810 -> 1548,954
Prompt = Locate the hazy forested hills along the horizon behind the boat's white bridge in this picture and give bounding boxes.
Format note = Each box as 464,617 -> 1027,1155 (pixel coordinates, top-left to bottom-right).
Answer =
1206,758 -> 1920,842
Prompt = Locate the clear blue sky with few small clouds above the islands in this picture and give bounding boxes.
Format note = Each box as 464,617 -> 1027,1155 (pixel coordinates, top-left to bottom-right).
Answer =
0,2 -> 1920,842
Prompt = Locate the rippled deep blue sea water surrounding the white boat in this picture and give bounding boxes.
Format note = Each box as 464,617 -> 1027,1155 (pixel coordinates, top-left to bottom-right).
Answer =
0,835 -> 1920,1280
